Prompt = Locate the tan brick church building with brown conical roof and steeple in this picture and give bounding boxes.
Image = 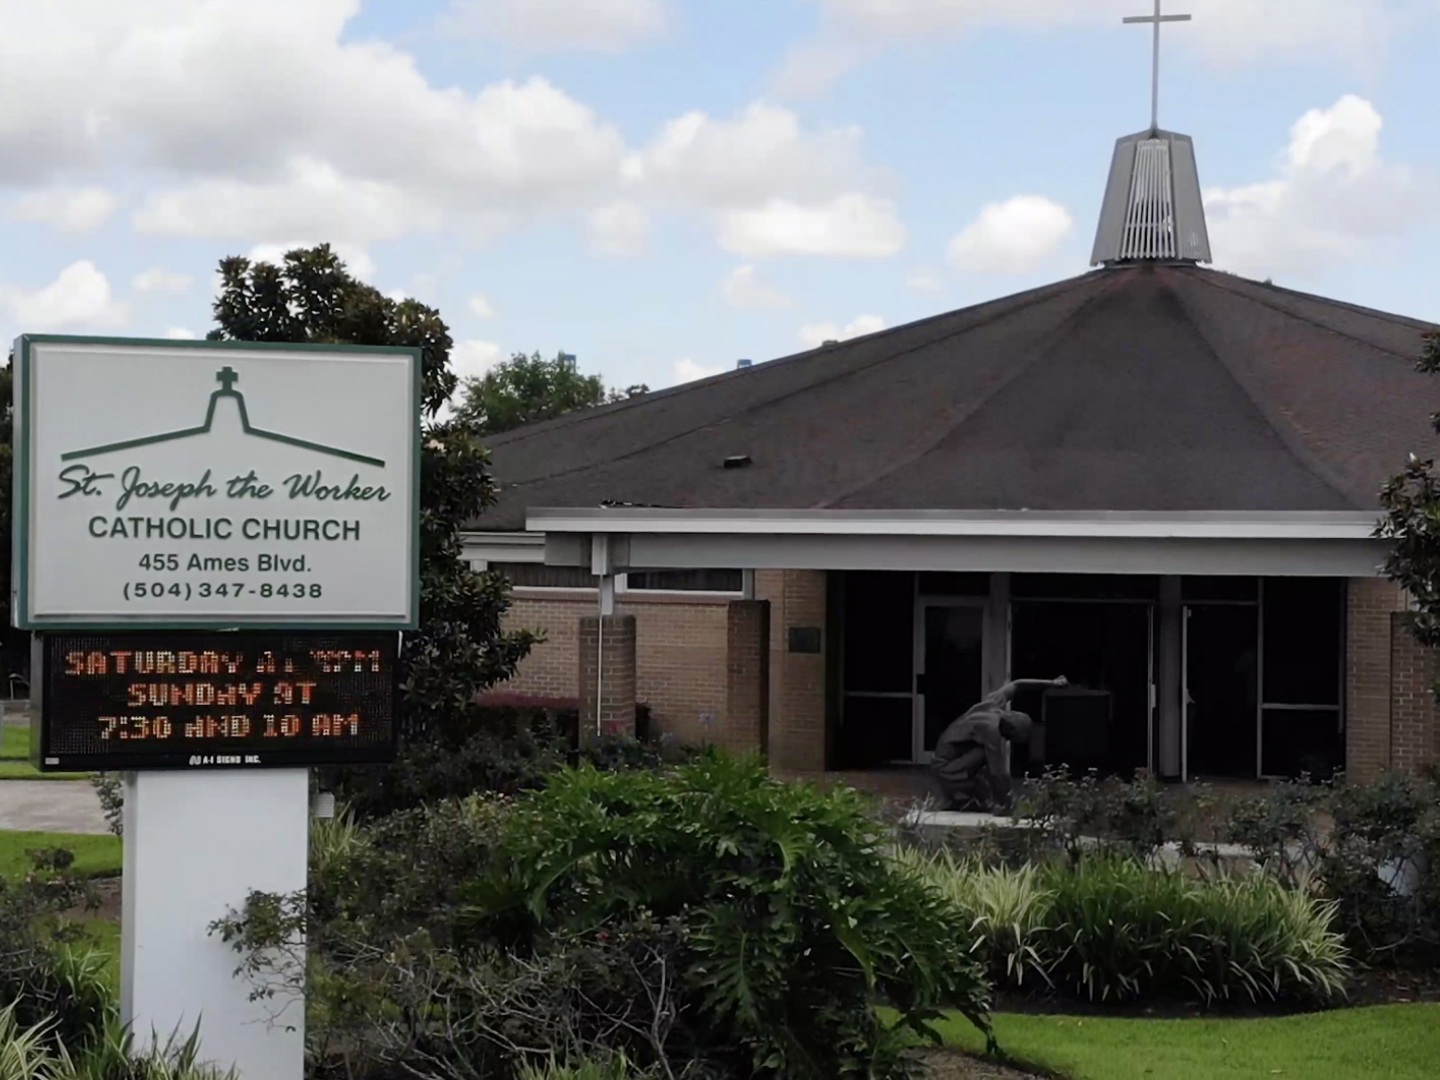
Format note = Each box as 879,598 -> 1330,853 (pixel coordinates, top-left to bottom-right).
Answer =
468,14 -> 1440,786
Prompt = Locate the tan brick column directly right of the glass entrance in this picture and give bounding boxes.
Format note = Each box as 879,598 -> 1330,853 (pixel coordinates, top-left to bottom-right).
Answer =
1345,577 -> 1403,783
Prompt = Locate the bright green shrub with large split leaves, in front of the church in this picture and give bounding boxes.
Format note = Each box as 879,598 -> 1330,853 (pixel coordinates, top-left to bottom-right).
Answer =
471,755 -> 988,1080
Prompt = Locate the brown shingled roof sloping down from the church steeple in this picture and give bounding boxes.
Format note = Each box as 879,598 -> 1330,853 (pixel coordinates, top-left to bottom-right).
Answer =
475,265 -> 1440,530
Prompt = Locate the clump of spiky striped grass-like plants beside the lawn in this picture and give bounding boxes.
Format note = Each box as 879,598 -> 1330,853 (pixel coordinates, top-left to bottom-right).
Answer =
901,852 -> 1348,1005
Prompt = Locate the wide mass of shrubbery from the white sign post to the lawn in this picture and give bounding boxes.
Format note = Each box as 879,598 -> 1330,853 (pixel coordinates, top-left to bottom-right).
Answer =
215,755 -> 988,1080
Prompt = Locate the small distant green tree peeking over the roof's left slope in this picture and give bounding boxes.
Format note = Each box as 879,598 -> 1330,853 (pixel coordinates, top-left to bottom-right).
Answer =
459,353 -> 649,435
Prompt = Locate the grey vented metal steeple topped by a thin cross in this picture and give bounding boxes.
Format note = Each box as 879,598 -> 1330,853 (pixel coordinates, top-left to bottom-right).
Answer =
1090,0 -> 1211,266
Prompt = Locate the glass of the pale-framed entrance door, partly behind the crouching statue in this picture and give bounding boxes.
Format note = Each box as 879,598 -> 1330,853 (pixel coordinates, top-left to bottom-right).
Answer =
912,598 -> 985,762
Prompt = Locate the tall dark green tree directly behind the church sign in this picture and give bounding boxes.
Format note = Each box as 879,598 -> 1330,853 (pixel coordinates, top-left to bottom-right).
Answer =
209,245 -> 536,747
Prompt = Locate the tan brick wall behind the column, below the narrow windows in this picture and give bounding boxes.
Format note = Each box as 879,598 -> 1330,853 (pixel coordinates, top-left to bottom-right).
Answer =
497,589 -> 729,743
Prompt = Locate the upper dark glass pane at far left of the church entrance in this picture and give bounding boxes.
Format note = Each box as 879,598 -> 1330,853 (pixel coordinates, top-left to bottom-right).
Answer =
845,573 -> 914,694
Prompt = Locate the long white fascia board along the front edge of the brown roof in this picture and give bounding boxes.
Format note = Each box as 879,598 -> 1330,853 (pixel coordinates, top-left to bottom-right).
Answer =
526,507 -> 1380,540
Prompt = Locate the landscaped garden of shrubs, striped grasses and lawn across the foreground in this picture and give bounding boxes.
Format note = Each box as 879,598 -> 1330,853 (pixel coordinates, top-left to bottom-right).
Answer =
0,747 -> 1440,1080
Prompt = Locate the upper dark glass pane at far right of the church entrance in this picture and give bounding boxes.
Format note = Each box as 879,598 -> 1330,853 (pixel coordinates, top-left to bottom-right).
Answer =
1263,577 -> 1342,706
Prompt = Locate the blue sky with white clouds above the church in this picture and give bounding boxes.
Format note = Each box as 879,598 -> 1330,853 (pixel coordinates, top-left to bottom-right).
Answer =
0,0 -> 1440,400
